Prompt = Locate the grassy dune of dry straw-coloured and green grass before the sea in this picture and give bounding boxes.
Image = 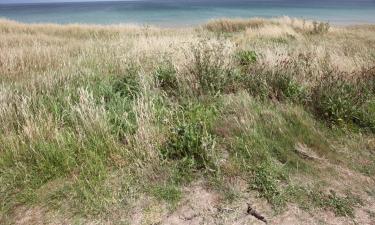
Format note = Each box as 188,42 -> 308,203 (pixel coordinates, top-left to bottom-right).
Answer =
0,17 -> 375,224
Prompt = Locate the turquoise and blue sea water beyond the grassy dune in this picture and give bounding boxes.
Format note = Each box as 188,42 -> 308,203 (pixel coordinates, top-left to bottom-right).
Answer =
0,0 -> 375,26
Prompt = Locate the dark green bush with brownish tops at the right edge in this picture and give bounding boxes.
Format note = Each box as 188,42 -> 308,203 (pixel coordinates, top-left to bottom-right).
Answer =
311,73 -> 374,129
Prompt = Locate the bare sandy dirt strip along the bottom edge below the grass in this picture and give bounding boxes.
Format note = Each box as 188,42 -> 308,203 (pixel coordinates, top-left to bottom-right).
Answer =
11,178 -> 375,225
